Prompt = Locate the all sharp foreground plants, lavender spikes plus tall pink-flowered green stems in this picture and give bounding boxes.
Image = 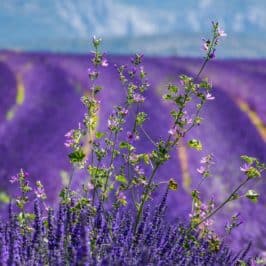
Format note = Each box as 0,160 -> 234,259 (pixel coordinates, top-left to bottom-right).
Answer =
0,23 -> 266,265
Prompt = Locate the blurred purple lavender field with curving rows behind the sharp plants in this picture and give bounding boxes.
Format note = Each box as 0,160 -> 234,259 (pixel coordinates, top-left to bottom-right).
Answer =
0,52 -> 266,252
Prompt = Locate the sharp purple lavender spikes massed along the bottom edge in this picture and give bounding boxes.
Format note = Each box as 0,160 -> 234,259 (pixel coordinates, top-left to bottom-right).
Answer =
0,189 -> 252,265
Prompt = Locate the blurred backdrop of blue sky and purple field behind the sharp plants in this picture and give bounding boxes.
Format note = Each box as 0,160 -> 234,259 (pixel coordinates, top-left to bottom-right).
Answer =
0,0 -> 266,254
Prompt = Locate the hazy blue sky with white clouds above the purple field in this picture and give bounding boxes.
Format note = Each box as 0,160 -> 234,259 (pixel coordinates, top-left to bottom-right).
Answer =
0,0 -> 266,58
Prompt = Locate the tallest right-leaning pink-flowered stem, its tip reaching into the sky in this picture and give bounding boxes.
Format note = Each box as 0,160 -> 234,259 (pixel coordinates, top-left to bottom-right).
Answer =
135,23 -> 224,230
